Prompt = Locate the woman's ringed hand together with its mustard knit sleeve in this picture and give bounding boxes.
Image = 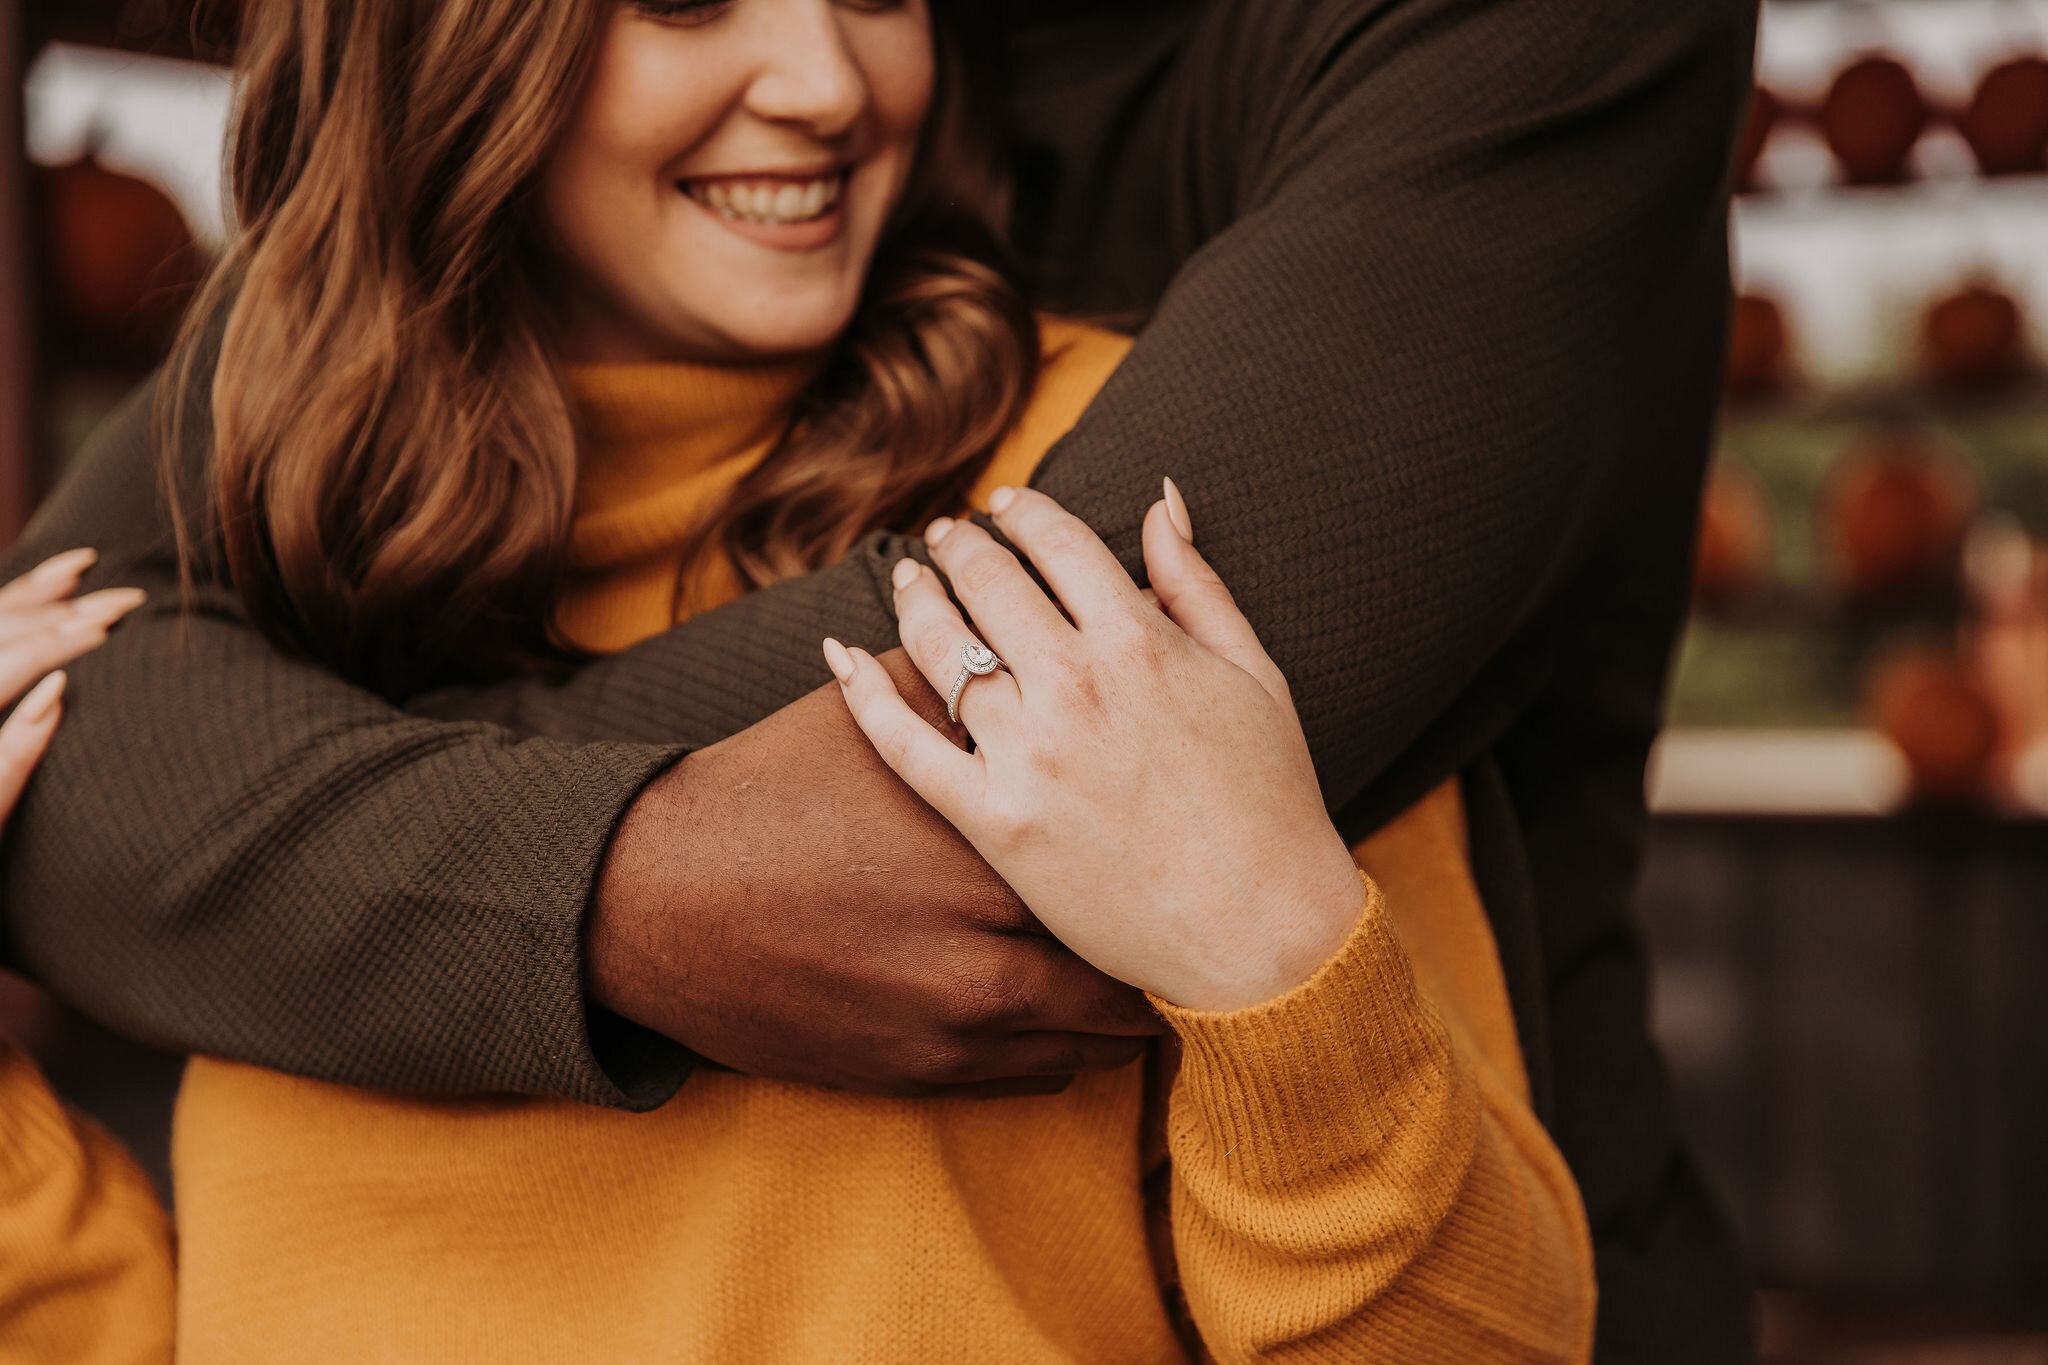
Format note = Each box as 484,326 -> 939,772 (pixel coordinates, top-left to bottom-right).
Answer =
825,487 -> 1595,1365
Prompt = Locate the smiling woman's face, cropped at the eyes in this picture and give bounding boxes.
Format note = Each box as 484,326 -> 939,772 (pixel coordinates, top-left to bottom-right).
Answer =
541,0 -> 934,362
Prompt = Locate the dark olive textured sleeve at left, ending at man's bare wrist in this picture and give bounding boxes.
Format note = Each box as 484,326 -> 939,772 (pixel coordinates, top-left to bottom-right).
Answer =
0,376 -> 688,1107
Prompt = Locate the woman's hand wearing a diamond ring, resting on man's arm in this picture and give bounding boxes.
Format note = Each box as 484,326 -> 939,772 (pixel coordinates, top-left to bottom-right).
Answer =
825,483 -> 1364,1009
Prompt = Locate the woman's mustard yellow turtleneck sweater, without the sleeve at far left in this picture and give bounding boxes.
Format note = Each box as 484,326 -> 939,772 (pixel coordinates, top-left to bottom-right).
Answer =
174,323 -> 1593,1365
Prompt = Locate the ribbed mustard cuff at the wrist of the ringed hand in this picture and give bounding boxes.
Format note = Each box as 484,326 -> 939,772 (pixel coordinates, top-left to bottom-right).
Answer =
1153,878 -> 1452,1189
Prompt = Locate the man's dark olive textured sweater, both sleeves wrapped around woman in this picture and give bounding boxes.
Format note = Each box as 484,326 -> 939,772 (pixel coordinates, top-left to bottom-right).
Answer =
0,0 -> 1755,1365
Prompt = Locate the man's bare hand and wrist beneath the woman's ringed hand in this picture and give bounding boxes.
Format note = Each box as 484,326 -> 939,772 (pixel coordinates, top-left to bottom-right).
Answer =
588,651 -> 1161,1095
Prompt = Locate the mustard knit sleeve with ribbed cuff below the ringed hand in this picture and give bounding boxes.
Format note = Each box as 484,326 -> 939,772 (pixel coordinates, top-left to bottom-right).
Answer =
1159,878 -> 1593,1365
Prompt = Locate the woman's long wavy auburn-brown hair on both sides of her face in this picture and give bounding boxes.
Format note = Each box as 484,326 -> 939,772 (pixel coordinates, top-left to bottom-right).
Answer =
162,0 -> 1038,696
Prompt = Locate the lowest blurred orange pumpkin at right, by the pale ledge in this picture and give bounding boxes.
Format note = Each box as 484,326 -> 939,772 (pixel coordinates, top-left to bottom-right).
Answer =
1866,645 -> 1999,802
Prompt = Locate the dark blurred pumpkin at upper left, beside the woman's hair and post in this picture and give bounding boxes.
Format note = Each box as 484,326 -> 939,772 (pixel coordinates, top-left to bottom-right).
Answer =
43,153 -> 205,354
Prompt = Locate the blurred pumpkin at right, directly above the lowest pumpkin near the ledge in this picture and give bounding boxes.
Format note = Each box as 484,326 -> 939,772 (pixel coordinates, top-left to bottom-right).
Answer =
1819,436 -> 1976,604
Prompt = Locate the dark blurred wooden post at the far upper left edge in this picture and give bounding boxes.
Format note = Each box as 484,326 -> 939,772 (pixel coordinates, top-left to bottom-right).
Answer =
0,0 -> 35,544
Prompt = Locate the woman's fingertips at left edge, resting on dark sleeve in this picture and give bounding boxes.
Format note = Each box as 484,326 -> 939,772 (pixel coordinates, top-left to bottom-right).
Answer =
0,551 -> 145,823
